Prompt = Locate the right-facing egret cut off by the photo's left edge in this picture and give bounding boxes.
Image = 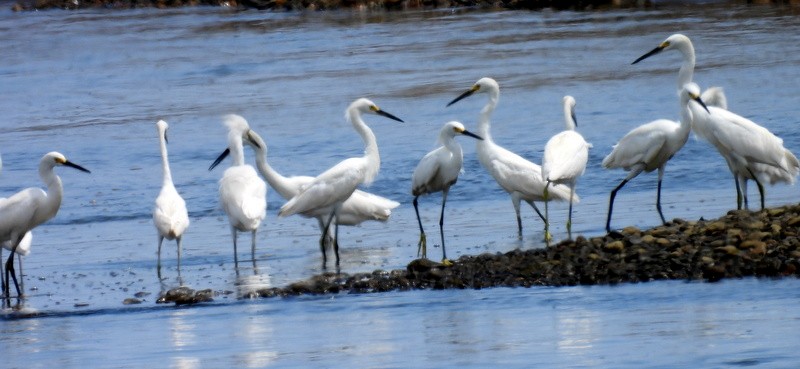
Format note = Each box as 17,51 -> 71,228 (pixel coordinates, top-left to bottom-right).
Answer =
0,151 -> 91,297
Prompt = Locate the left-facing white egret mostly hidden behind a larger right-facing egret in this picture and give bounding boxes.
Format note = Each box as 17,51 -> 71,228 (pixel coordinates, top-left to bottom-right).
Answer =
210,130 -> 400,257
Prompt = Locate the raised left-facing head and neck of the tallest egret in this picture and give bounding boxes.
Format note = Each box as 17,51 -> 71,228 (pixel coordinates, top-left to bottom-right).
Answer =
631,33 -> 728,109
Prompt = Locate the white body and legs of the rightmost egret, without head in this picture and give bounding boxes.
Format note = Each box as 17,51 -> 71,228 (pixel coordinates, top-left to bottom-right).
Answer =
690,84 -> 800,209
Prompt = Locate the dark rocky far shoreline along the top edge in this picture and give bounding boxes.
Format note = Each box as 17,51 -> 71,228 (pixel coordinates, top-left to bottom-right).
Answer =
12,0 -> 651,11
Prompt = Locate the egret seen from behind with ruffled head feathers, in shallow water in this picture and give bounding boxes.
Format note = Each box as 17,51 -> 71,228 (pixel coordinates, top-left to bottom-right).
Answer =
219,114 -> 267,265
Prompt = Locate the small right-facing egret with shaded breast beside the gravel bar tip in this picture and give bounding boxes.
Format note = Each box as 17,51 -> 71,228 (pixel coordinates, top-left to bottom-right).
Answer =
411,122 -> 482,264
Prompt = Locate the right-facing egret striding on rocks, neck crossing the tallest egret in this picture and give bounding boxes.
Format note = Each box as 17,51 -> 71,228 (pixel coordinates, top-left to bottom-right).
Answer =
603,83 -> 705,232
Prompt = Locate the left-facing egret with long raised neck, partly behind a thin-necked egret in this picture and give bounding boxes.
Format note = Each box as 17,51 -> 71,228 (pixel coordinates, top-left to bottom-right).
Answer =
447,77 -> 579,237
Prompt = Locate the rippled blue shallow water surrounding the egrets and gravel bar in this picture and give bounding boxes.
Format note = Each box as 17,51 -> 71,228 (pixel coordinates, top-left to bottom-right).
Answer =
0,4 -> 800,367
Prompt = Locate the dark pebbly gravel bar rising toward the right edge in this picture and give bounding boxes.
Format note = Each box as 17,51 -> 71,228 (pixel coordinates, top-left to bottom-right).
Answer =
161,205 -> 800,303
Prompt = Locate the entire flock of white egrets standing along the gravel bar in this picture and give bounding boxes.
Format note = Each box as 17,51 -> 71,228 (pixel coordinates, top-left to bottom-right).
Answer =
0,34 -> 800,297
